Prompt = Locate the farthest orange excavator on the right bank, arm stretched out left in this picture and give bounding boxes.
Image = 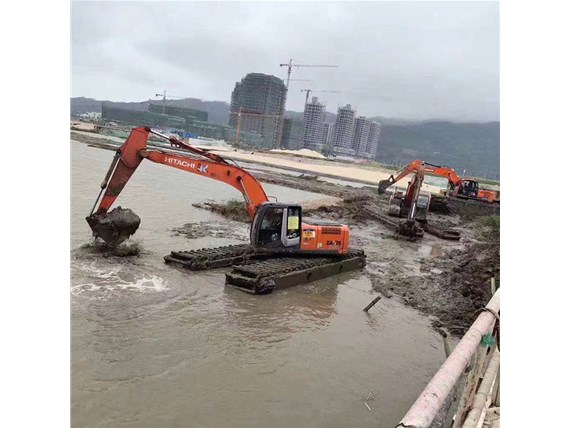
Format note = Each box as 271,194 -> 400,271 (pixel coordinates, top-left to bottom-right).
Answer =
378,160 -> 498,203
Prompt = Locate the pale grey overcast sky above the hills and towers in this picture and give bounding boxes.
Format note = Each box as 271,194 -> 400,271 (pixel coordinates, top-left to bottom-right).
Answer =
71,1 -> 499,121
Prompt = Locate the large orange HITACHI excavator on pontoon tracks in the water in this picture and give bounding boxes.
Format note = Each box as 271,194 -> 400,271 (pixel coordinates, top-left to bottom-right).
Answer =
86,127 -> 366,294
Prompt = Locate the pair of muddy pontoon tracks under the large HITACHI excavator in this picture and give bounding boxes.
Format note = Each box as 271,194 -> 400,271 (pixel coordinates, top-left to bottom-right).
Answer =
164,244 -> 366,294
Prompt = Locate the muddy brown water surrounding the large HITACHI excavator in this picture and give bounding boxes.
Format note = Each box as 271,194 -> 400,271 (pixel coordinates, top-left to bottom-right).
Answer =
71,142 -> 444,428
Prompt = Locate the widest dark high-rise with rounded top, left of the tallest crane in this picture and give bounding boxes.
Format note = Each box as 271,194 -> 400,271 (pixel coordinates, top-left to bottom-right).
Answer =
229,73 -> 287,147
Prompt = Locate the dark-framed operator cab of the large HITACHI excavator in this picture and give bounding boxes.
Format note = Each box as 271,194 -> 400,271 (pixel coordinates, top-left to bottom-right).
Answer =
250,202 -> 301,249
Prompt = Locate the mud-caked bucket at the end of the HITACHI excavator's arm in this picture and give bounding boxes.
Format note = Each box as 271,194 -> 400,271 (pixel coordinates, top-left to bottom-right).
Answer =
85,207 -> 141,246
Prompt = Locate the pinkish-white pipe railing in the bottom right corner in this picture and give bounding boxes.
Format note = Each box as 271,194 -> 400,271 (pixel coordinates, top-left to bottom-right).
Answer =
396,288 -> 500,428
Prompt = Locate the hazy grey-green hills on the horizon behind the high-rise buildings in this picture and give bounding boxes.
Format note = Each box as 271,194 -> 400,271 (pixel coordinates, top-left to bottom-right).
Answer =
71,97 -> 500,179
